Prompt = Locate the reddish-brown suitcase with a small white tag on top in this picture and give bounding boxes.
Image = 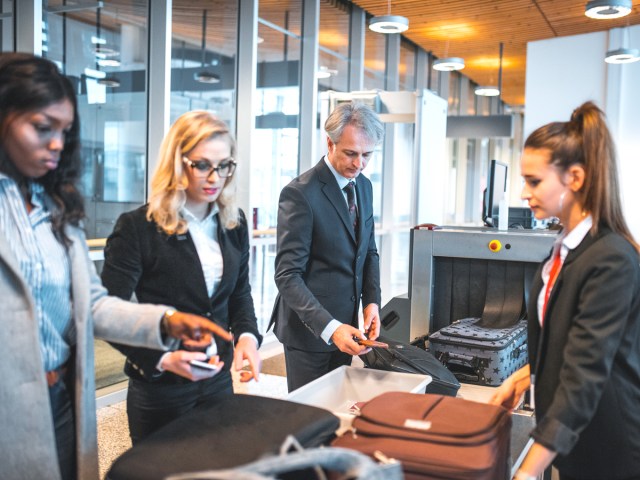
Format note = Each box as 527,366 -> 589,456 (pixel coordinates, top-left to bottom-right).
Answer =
332,392 -> 511,480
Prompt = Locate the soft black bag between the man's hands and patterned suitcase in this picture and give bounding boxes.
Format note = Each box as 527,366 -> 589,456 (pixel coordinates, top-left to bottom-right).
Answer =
361,337 -> 460,397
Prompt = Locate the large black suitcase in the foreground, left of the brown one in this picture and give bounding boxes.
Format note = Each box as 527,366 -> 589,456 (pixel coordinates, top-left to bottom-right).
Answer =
106,395 -> 340,480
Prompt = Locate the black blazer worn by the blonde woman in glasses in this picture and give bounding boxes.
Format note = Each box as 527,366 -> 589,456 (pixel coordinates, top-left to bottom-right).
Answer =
102,206 -> 262,383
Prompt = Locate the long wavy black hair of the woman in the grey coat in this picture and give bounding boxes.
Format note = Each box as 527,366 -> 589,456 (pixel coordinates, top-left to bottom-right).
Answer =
0,53 -> 84,243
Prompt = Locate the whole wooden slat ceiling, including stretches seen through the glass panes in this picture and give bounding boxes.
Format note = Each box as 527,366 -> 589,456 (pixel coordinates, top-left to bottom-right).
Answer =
49,0 -> 640,105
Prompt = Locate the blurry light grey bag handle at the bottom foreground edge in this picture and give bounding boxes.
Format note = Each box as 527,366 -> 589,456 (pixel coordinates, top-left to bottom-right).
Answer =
165,436 -> 404,480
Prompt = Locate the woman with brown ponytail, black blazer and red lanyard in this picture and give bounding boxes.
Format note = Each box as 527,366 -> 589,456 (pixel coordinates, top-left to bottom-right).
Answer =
492,102 -> 640,480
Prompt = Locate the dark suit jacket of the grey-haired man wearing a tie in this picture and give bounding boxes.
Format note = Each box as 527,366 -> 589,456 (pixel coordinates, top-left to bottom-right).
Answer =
272,159 -> 380,352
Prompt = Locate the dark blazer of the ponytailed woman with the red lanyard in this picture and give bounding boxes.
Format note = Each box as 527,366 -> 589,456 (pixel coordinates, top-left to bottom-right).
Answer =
528,228 -> 640,479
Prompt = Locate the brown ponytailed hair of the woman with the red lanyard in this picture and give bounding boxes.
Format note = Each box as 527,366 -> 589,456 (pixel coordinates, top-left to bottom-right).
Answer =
524,102 -> 640,250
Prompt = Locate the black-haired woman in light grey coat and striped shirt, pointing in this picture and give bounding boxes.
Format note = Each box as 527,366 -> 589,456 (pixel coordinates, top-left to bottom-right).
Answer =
0,53 -> 231,480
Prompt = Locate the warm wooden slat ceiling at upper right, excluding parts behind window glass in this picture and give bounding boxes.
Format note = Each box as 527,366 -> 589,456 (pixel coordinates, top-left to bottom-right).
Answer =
353,0 -> 640,105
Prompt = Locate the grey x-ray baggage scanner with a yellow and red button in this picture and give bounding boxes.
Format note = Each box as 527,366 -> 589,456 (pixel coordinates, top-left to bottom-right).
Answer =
381,227 -> 558,342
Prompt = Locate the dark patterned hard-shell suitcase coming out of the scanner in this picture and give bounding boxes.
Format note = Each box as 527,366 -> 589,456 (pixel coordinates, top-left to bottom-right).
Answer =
429,318 -> 528,386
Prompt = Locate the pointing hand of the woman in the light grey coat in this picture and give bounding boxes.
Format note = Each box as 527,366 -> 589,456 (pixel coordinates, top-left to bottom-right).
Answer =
162,312 -> 233,350
